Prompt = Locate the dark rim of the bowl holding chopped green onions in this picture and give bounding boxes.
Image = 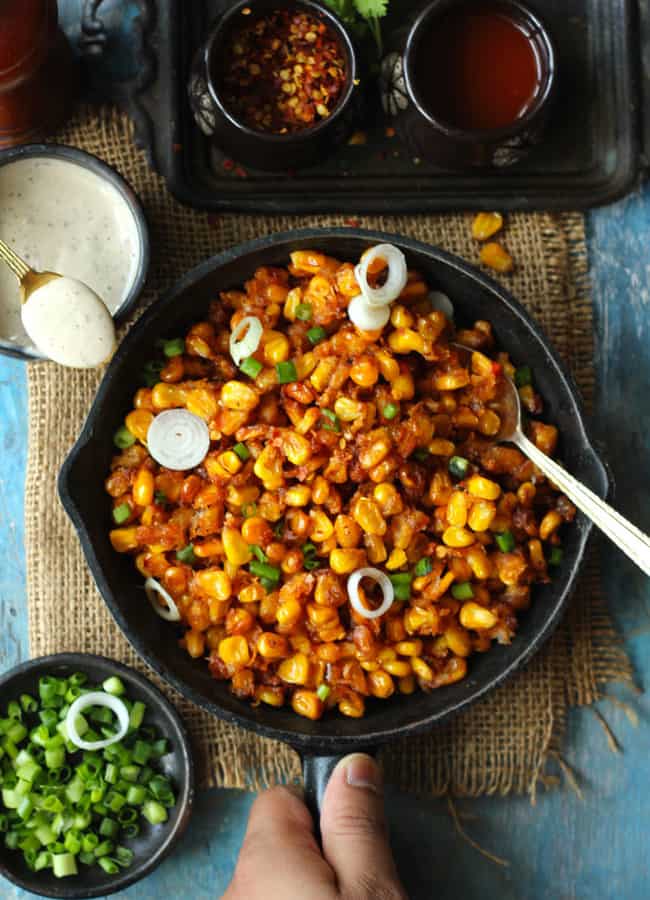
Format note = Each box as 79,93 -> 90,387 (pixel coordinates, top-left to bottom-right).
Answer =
0,653 -> 195,900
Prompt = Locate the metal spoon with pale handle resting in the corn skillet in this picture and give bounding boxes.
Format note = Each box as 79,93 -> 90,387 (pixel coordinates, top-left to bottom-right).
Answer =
453,344 -> 650,575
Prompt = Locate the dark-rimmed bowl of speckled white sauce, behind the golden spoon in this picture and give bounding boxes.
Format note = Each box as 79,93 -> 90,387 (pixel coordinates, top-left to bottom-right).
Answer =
0,144 -> 149,359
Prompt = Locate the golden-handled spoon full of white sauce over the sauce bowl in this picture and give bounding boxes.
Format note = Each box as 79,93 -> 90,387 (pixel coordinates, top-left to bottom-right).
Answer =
0,239 -> 115,369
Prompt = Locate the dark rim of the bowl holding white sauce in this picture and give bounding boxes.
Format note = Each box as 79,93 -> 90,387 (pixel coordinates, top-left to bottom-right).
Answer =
0,143 -> 151,360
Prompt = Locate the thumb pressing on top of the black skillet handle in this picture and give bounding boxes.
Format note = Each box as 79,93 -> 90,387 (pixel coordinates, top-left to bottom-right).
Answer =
320,753 -> 406,900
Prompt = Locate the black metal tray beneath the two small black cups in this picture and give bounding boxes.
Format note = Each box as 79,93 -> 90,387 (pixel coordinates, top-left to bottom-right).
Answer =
100,0 -> 646,215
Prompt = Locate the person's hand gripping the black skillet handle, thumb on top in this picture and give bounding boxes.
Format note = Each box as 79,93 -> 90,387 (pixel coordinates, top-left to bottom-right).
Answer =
222,753 -> 407,900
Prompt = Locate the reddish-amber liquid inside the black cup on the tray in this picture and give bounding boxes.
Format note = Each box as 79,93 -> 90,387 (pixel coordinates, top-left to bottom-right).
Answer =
415,3 -> 545,131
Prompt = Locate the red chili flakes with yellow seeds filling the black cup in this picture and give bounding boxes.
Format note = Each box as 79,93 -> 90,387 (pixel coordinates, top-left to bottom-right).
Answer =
221,9 -> 346,134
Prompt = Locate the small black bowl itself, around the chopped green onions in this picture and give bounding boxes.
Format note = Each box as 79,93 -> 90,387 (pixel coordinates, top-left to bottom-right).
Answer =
0,653 -> 194,900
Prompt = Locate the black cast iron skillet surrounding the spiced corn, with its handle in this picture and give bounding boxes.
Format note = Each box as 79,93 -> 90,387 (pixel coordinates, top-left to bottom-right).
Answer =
59,228 -> 608,809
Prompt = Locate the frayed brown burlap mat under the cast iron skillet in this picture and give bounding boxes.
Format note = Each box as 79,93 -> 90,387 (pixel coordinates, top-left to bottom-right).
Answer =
25,111 -> 630,796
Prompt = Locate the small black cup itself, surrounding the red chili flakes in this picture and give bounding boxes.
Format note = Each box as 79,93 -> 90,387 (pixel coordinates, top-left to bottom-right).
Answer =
188,0 -> 360,171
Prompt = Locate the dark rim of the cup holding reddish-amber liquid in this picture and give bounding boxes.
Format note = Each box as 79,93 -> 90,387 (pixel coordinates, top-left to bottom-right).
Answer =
403,0 -> 557,143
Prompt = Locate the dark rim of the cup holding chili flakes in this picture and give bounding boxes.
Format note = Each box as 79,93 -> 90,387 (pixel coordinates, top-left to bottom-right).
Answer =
202,0 -> 358,147
